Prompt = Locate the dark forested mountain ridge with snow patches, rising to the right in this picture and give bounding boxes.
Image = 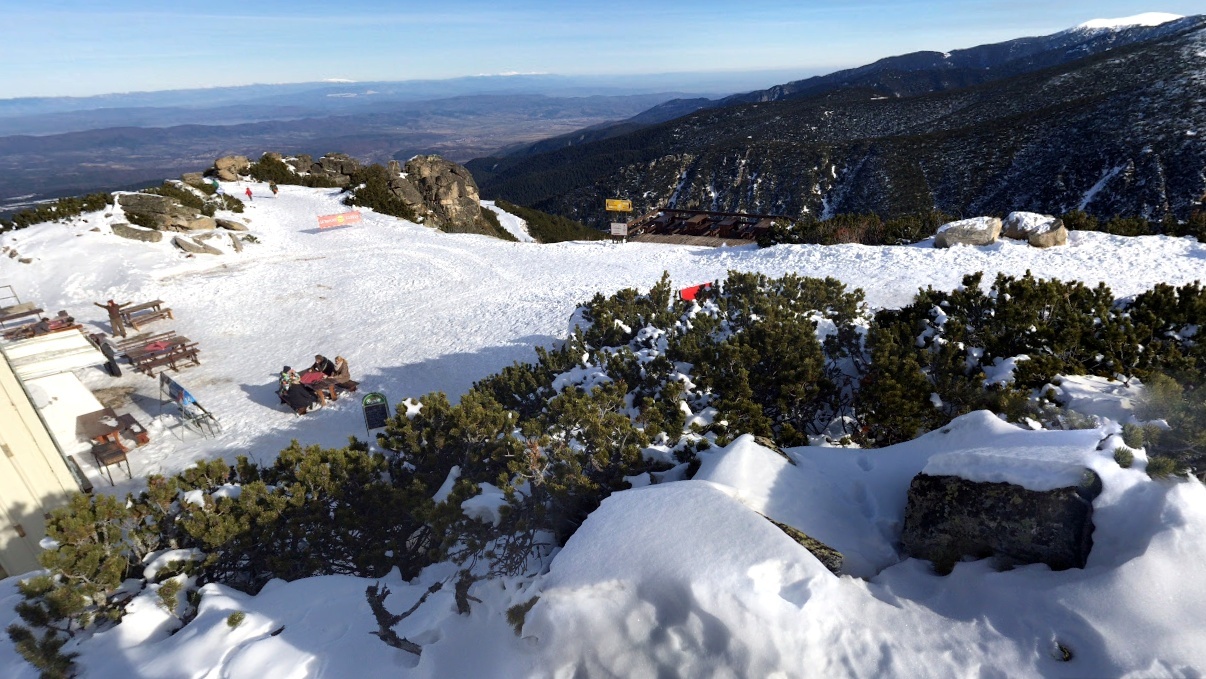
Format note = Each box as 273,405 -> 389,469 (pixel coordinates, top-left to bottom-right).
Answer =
467,16 -> 1206,226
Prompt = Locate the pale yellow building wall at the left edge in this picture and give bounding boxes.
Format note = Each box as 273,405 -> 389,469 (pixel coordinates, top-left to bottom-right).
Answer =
0,357 -> 78,575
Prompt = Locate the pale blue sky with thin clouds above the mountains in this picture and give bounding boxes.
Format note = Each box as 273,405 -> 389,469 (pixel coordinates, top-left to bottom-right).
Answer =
0,0 -> 1204,99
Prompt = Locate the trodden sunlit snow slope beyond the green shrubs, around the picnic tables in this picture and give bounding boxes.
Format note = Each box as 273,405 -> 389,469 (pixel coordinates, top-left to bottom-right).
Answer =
0,183 -> 1206,491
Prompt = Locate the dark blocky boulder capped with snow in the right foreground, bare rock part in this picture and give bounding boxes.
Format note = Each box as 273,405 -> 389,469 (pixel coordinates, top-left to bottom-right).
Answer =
901,469 -> 1101,572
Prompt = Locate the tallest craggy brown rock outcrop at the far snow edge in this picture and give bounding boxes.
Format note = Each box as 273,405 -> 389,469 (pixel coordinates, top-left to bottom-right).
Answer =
405,156 -> 491,234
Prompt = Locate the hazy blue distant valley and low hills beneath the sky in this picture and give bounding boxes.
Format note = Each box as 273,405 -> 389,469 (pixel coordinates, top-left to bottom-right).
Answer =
0,93 -> 704,211
